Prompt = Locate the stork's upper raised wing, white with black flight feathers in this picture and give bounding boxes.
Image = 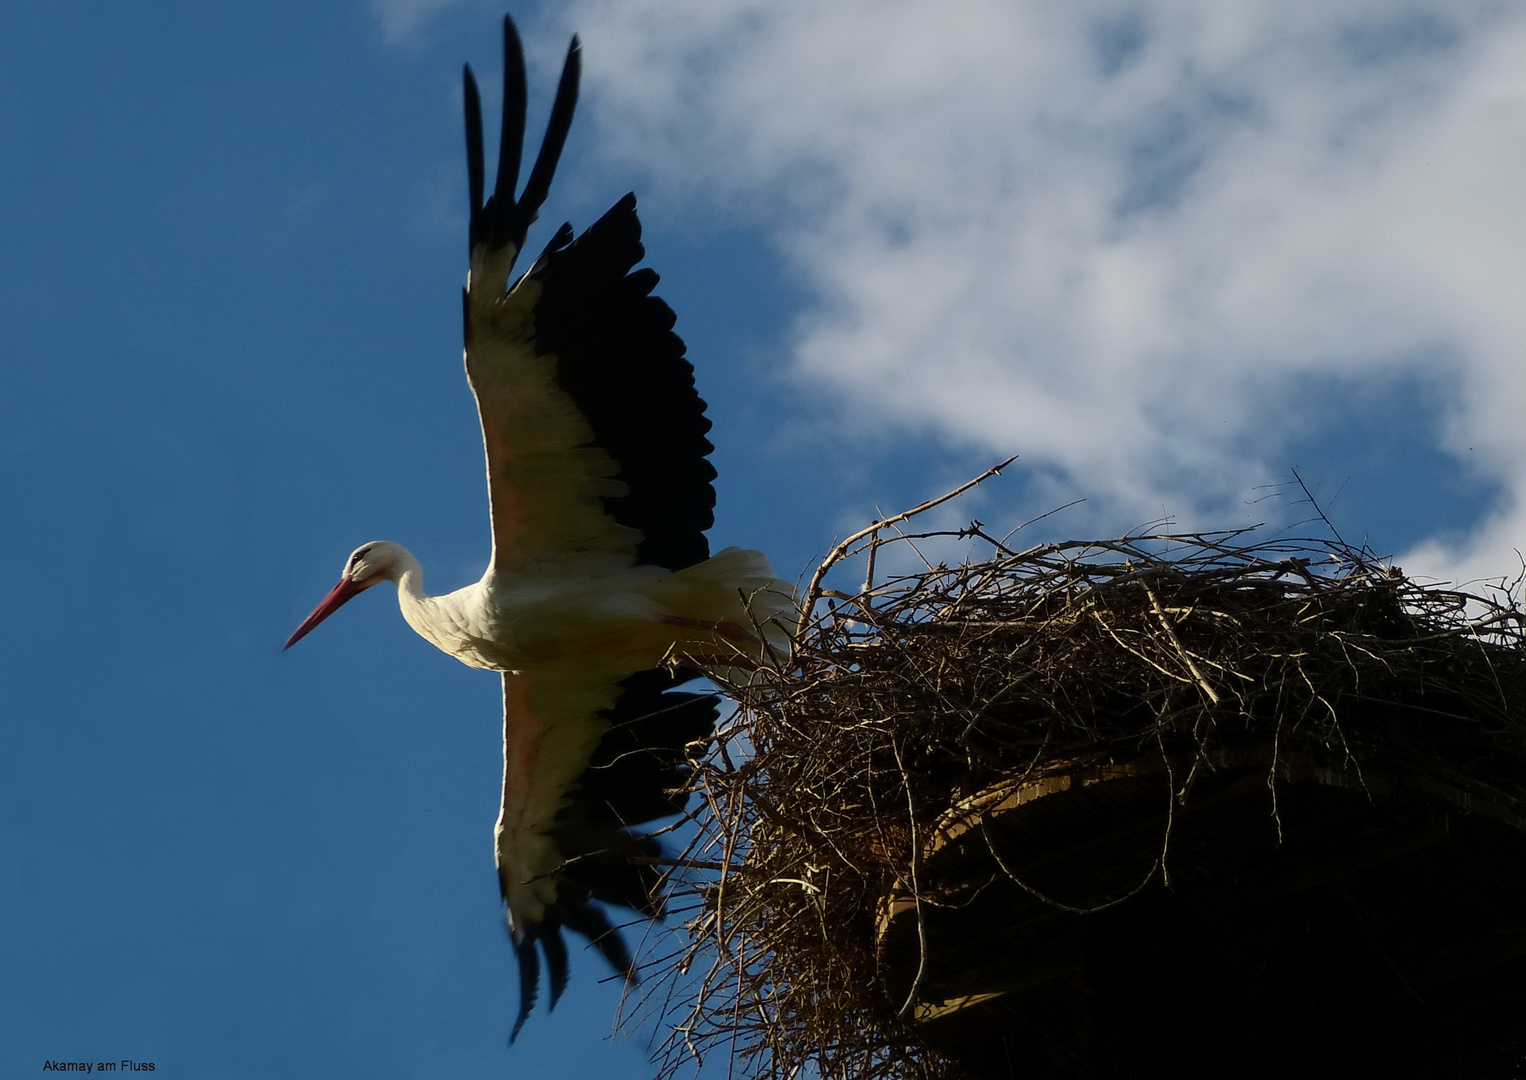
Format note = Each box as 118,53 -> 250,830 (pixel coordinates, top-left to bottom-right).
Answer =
464,18 -> 716,575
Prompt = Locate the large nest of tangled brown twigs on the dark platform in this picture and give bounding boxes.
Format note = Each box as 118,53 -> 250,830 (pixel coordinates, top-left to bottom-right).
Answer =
643,475 -> 1526,1080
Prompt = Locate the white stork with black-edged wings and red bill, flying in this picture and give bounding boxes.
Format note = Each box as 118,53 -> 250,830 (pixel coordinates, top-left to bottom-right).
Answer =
287,17 -> 794,1040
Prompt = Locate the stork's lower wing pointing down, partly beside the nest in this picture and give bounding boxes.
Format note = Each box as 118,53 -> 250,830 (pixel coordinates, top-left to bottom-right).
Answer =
494,667 -> 717,1040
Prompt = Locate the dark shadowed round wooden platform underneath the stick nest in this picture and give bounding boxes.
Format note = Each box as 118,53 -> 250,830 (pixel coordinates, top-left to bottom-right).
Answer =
877,746 -> 1526,1080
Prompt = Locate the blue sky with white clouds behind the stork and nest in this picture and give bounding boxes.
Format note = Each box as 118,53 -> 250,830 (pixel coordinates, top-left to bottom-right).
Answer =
0,0 -> 1526,1080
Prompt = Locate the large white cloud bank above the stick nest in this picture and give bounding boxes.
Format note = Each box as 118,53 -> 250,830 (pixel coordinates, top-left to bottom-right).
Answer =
566,0 -> 1526,582
